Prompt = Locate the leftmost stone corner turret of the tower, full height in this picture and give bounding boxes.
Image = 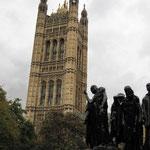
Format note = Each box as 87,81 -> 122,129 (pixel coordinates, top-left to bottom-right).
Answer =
26,0 -> 47,119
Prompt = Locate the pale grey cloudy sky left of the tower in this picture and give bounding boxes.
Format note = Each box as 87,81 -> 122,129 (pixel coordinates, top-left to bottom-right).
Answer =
0,0 -> 36,107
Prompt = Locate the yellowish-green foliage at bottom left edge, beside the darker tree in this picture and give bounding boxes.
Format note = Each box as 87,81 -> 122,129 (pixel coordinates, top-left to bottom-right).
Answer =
0,101 -> 19,150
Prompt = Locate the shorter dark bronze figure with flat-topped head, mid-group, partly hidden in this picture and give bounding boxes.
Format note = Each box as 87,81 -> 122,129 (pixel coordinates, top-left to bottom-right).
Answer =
110,93 -> 125,146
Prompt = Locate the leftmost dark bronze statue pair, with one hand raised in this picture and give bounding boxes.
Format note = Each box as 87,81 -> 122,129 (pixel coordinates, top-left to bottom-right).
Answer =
84,85 -> 111,148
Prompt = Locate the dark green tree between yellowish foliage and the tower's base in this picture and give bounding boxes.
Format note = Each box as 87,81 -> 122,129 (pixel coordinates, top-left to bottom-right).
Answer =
9,98 -> 36,150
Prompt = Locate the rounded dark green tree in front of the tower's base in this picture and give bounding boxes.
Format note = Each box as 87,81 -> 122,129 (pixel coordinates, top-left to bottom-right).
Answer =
36,112 -> 85,150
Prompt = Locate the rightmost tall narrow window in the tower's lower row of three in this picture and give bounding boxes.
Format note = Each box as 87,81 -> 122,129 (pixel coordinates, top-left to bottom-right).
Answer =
56,80 -> 62,104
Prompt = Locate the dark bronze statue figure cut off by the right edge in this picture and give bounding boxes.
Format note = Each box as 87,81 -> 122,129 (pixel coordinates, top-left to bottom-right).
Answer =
142,83 -> 150,150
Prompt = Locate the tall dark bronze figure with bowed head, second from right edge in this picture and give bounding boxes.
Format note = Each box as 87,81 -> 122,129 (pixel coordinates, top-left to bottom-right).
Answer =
123,86 -> 143,150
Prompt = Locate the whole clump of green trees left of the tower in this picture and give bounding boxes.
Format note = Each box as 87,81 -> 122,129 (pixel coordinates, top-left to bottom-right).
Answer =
0,86 -> 36,150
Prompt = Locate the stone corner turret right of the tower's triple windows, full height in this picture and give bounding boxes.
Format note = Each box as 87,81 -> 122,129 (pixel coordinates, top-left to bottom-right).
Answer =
63,0 -> 79,112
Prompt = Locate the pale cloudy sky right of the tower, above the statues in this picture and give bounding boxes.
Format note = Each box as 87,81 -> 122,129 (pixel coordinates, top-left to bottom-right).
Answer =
88,0 -> 150,109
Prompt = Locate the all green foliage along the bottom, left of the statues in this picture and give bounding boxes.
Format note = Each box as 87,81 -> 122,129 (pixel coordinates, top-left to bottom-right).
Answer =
0,86 -> 86,150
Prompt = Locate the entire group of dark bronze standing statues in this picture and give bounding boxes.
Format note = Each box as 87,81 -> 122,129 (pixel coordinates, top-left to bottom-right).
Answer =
84,83 -> 150,150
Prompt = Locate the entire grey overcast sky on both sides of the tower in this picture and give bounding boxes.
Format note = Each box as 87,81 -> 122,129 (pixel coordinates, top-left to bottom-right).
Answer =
0,0 -> 150,107
